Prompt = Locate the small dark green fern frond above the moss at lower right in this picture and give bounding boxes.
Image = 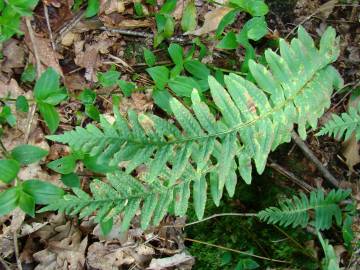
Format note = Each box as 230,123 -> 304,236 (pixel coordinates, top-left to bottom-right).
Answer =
258,189 -> 351,230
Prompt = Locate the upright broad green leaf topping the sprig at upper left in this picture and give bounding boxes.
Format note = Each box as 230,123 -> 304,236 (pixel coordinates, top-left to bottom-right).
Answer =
34,68 -> 60,101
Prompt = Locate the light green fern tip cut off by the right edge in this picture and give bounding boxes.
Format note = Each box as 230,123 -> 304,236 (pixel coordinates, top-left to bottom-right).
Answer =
317,104 -> 360,141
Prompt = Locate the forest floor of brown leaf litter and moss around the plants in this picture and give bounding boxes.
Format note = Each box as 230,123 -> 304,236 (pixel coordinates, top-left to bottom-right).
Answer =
0,0 -> 360,270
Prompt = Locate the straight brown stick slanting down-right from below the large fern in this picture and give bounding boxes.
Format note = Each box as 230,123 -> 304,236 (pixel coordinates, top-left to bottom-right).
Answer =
291,131 -> 339,187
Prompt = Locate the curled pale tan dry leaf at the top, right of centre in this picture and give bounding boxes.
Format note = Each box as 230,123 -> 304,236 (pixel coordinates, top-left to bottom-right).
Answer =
184,7 -> 232,36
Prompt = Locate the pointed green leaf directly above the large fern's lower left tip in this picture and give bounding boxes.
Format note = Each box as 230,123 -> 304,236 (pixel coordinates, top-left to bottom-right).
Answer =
22,179 -> 65,204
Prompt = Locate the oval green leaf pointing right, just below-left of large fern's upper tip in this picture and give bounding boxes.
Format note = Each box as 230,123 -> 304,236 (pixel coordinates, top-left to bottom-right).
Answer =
11,144 -> 49,165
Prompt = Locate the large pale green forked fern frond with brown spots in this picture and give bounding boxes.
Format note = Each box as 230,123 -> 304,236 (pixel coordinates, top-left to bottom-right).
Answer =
45,27 -> 342,230
